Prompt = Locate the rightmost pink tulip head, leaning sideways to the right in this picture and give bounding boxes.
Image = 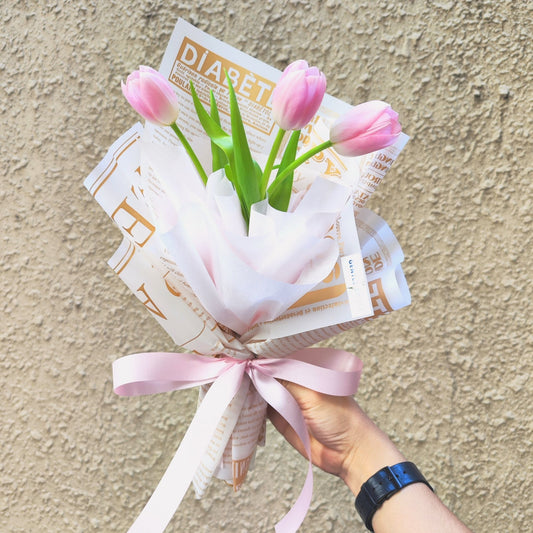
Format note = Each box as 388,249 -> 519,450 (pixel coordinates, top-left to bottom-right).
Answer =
329,100 -> 402,157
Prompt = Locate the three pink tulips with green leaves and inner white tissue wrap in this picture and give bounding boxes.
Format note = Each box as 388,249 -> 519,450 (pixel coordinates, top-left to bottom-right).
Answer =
122,60 -> 401,335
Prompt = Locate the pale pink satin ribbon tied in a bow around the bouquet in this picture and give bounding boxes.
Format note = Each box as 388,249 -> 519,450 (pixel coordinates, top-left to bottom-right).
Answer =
113,348 -> 362,533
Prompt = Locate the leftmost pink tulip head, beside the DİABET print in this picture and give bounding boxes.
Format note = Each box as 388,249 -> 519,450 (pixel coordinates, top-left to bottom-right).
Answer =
122,66 -> 178,126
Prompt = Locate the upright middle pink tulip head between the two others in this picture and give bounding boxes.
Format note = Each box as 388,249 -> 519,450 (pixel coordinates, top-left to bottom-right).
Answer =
272,59 -> 326,130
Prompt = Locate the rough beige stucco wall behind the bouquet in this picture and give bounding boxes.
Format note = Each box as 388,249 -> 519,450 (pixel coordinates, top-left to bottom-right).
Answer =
0,0 -> 533,533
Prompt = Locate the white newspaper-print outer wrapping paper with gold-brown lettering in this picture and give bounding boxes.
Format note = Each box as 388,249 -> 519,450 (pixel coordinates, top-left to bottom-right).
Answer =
85,20 -> 410,528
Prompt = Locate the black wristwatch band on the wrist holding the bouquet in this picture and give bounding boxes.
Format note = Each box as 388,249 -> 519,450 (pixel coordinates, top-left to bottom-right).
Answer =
355,462 -> 433,531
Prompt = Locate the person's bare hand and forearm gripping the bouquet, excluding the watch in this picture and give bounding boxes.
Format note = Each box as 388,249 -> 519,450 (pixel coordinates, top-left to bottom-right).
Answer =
268,383 -> 471,533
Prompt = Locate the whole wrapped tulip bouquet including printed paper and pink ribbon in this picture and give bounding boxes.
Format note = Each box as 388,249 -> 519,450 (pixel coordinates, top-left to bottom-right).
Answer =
86,21 -> 408,533
